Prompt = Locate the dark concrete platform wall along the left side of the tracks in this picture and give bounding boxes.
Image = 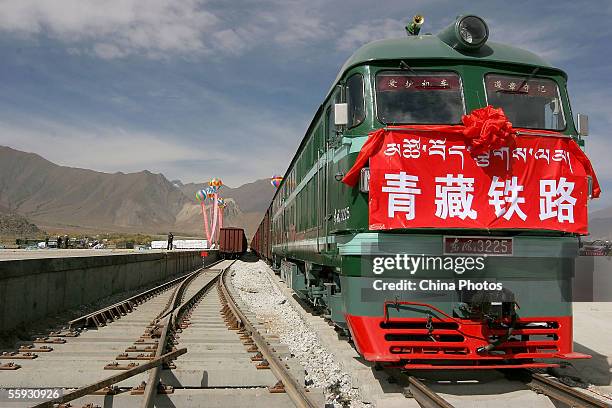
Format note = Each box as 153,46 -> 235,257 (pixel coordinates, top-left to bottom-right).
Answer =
0,251 -> 217,333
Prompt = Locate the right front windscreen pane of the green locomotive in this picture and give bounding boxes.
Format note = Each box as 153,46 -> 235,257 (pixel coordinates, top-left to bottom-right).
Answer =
485,74 -> 565,130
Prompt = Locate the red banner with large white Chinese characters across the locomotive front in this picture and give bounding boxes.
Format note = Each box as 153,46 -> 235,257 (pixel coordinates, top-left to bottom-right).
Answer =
364,131 -> 596,234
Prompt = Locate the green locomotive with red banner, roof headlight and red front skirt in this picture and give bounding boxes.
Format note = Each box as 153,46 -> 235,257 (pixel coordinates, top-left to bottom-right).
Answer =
251,15 -> 600,369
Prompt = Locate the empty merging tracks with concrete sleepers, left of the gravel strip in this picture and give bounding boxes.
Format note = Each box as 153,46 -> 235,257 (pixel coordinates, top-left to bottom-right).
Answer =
0,261 -> 324,408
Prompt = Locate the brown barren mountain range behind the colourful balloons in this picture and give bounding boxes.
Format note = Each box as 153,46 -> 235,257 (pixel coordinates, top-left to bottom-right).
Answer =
0,146 -> 275,236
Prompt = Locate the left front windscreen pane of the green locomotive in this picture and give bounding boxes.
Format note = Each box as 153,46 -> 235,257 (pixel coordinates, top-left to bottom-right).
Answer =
376,71 -> 465,124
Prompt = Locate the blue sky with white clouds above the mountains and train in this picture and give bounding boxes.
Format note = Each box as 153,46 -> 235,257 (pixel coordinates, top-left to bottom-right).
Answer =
0,0 -> 612,206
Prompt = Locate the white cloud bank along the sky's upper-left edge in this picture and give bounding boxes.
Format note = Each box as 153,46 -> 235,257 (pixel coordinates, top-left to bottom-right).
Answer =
0,0 -> 332,59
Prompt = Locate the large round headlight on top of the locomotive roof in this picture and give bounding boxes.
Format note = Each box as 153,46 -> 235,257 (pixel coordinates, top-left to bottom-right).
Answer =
438,15 -> 489,50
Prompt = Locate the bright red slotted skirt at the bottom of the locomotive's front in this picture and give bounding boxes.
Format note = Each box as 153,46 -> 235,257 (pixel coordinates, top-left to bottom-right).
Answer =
346,315 -> 590,368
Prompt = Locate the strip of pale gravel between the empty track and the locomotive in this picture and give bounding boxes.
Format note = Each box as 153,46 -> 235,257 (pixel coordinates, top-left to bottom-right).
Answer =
231,260 -> 370,407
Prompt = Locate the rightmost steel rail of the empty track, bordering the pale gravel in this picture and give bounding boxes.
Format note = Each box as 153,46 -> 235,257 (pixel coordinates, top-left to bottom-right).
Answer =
219,268 -> 318,408
